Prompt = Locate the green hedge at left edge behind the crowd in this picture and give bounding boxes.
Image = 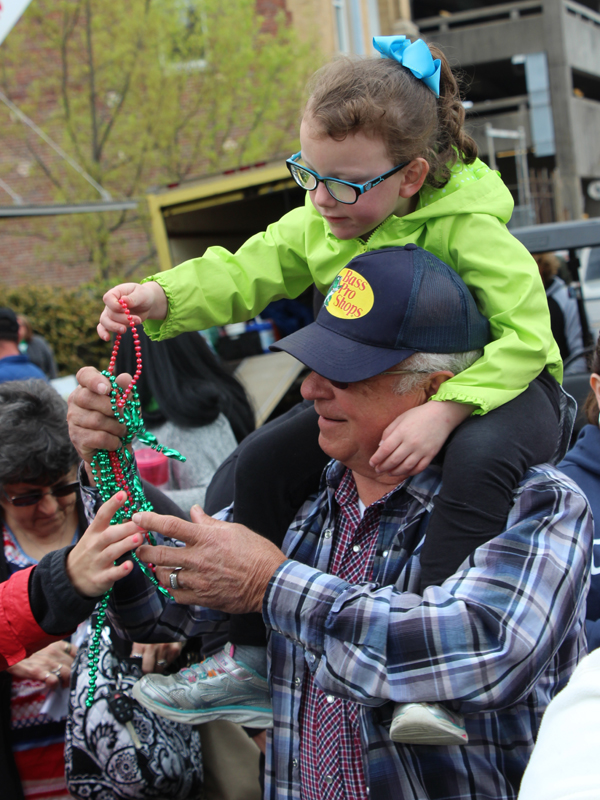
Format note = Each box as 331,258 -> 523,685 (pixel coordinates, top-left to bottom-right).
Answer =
0,285 -> 111,375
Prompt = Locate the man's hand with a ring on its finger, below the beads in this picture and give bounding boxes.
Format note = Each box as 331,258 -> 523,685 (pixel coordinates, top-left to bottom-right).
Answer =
133,506 -> 285,614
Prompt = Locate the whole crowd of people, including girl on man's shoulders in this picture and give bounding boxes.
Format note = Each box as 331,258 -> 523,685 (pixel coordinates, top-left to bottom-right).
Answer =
0,36 -> 600,800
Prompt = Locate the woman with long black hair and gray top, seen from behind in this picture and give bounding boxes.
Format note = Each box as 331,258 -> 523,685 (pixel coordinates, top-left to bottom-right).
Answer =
115,325 -> 254,510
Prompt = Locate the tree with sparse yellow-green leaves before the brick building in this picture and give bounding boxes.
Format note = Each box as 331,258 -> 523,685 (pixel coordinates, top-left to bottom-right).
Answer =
0,0 -> 318,283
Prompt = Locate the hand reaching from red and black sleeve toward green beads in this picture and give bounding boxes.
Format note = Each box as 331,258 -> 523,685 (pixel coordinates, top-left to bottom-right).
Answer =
67,491 -> 144,597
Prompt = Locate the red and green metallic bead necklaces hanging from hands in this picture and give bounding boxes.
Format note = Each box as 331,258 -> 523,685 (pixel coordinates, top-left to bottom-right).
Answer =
85,298 -> 186,708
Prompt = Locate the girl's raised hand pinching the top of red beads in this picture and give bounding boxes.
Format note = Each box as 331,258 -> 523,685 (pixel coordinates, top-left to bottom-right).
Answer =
97,281 -> 169,342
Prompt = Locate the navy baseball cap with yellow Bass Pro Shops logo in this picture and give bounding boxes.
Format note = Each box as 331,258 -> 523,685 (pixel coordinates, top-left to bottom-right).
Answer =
270,244 -> 490,383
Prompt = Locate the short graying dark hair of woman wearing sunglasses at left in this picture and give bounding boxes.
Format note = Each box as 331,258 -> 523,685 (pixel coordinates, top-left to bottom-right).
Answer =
0,380 -> 78,488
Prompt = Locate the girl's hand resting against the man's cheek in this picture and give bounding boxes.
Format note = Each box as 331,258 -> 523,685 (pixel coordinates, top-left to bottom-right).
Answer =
369,400 -> 475,478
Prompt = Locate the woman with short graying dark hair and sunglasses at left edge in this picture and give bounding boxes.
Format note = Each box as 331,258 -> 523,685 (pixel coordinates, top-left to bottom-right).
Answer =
0,380 -> 105,800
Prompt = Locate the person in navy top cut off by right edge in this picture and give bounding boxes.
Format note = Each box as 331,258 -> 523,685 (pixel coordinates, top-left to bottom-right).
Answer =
558,337 -> 600,650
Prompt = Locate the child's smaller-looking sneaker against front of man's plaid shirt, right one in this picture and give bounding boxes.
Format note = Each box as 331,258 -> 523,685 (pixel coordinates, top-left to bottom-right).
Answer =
390,703 -> 469,744
